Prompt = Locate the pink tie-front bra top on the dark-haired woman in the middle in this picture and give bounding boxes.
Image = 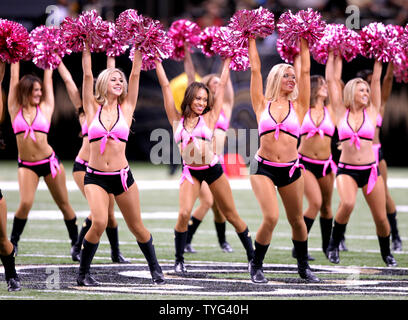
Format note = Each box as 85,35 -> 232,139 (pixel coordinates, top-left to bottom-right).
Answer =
174,115 -> 213,149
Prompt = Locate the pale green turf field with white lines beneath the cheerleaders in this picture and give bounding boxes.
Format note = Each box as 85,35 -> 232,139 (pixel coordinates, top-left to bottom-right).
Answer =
0,161 -> 408,300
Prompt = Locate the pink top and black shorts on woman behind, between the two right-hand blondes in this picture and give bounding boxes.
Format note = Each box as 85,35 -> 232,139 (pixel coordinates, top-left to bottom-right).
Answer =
299,107 -> 337,179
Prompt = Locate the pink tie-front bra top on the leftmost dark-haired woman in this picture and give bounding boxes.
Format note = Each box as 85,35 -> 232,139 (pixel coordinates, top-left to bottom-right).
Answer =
13,106 -> 50,141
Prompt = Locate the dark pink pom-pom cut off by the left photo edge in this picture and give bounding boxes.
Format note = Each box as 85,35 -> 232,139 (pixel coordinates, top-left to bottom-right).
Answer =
0,19 -> 29,63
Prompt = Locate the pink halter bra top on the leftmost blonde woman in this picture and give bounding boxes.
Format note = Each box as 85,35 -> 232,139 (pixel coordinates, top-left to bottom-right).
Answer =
88,105 -> 129,154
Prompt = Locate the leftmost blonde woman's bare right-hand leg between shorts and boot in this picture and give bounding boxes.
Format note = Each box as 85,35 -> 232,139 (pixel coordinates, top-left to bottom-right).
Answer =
115,183 -> 150,243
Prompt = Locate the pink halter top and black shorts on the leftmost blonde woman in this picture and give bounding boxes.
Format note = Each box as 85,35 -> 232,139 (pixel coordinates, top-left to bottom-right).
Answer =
84,105 -> 135,196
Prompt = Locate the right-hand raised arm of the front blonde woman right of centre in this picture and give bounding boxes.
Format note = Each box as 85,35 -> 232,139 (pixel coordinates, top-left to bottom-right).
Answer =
296,38 -> 310,122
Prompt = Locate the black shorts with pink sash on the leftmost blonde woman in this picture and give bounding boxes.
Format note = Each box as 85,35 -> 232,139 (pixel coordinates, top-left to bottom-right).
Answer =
84,166 -> 135,196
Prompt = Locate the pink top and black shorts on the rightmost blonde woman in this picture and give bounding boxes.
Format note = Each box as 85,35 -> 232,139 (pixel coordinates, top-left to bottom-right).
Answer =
337,109 -> 380,194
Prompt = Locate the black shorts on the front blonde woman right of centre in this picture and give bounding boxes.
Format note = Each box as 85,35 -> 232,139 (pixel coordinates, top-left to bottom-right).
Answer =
249,159 -> 302,187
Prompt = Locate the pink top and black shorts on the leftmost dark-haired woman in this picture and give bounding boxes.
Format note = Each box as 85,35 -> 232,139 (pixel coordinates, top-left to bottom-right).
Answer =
12,106 -> 61,178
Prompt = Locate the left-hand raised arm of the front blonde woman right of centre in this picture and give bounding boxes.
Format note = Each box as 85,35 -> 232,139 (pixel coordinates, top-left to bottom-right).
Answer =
248,39 -> 265,113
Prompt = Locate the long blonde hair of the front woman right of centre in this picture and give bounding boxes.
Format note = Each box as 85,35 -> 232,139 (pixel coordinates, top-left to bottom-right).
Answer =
265,63 -> 299,101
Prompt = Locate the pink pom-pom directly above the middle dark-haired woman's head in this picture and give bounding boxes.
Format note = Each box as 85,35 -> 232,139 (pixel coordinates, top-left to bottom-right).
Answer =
167,19 -> 201,61
